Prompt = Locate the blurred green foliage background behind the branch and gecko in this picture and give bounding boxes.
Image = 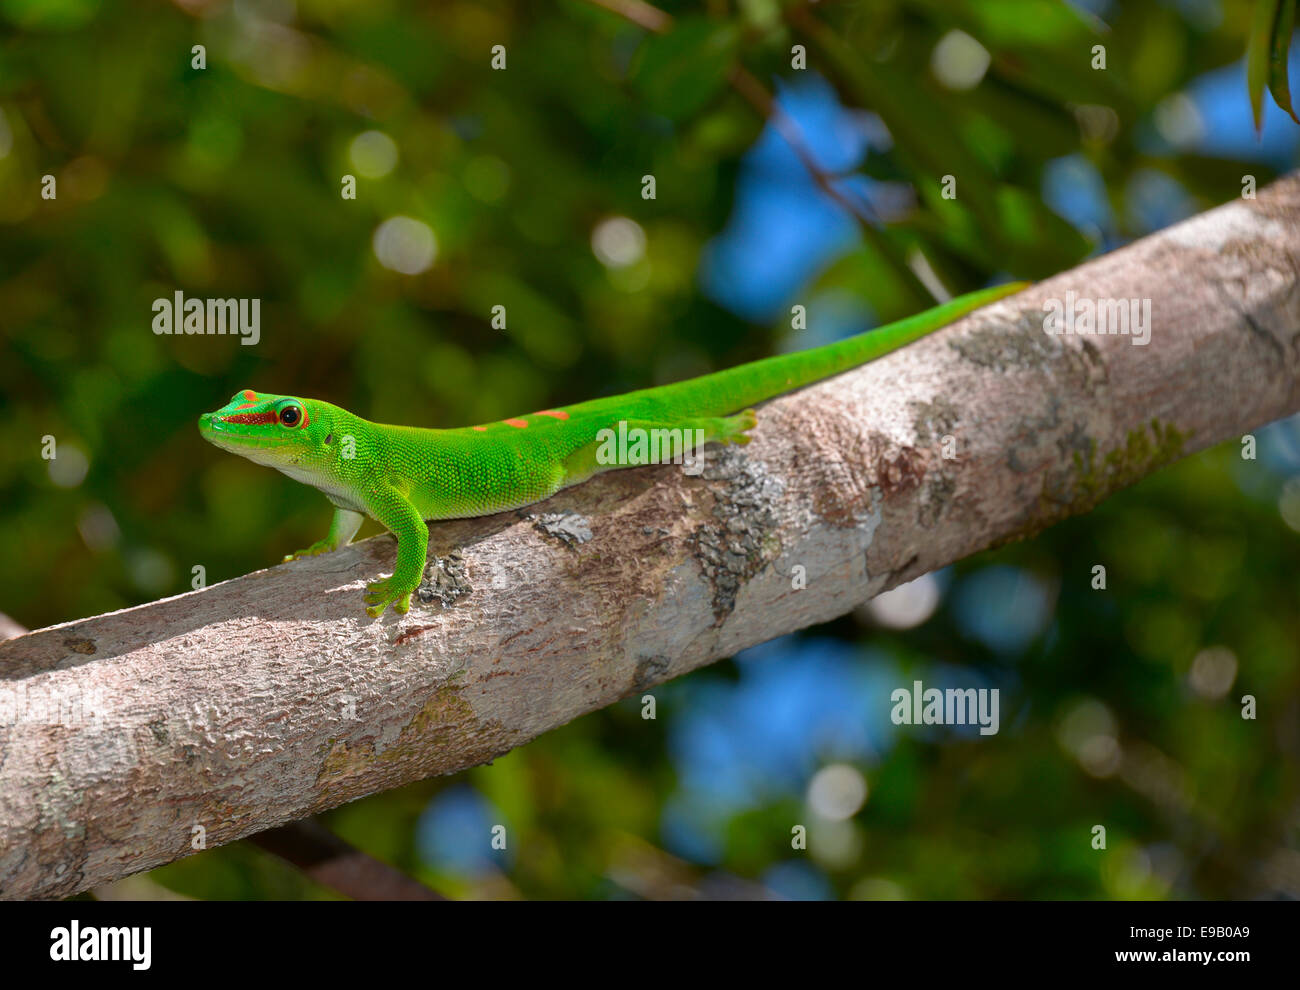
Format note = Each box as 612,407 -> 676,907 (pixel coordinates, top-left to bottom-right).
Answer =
0,0 -> 1300,898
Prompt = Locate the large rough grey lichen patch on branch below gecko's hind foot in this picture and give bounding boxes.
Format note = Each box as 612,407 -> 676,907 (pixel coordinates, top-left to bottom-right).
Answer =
688,447 -> 785,626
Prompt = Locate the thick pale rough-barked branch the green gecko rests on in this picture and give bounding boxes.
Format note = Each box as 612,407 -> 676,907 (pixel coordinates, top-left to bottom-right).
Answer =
0,177 -> 1300,898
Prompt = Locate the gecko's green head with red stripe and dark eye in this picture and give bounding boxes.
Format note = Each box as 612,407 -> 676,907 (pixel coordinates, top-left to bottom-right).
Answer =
199,388 -> 335,473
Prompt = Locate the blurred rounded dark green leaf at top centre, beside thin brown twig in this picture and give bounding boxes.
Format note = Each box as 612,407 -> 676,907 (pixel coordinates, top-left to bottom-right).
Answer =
632,18 -> 740,121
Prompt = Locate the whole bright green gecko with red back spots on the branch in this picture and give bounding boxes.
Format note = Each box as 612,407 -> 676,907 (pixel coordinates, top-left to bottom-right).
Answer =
199,282 -> 1026,618
